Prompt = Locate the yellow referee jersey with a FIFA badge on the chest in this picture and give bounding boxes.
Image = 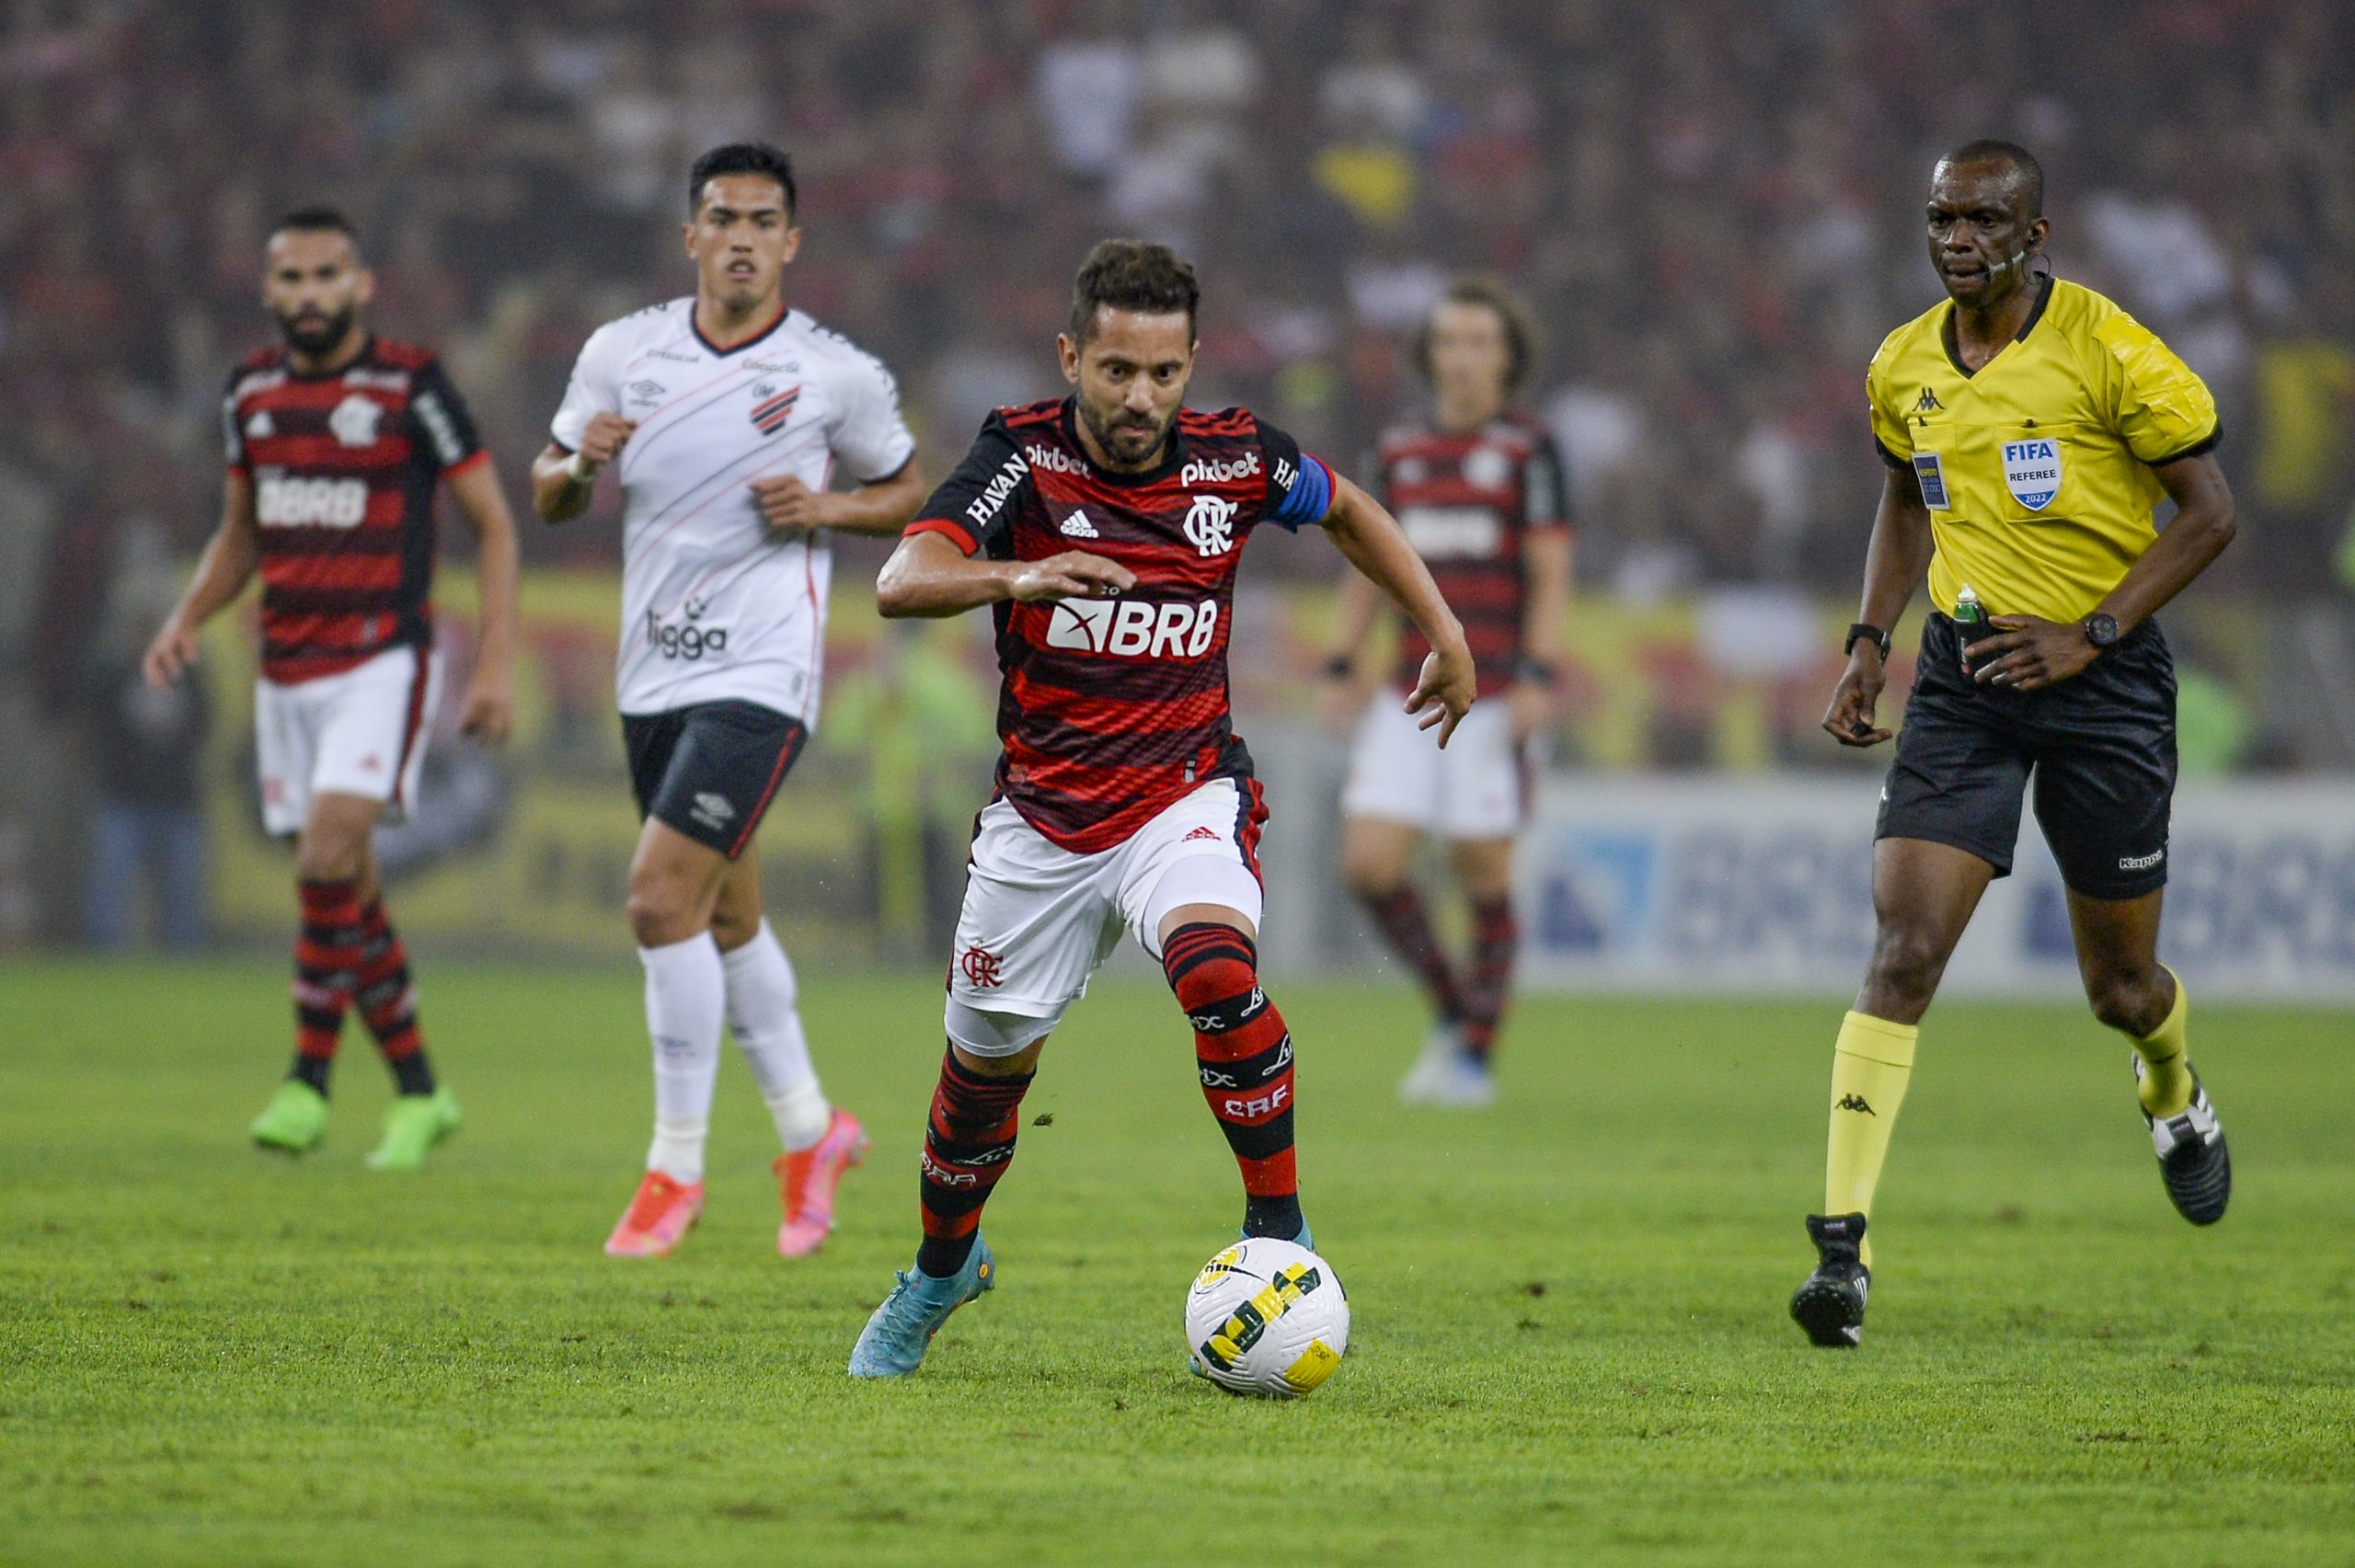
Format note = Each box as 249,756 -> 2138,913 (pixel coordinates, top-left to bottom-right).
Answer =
1866,278 -> 2216,622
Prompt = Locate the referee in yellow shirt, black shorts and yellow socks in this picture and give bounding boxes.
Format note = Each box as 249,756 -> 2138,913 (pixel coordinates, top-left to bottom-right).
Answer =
1790,142 -> 2233,1346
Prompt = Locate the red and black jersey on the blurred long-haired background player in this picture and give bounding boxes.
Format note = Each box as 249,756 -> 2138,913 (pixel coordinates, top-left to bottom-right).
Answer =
1373,415 -> 1571,697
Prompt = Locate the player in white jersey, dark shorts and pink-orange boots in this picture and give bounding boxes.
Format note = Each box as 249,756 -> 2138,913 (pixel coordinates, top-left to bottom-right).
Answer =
533,143 -> 924,1257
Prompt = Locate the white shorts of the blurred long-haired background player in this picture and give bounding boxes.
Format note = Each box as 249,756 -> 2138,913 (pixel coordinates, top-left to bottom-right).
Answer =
1340,690 -> 1531,838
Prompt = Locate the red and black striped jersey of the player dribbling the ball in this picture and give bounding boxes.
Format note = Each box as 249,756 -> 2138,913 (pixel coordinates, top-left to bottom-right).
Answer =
907,398 -> 1333,854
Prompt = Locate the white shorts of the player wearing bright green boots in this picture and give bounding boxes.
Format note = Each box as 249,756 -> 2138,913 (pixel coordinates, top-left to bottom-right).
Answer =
254,647 -> 442,833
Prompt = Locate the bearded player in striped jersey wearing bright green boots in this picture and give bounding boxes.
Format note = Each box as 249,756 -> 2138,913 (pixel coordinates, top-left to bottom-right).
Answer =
146,207 -> 516,1170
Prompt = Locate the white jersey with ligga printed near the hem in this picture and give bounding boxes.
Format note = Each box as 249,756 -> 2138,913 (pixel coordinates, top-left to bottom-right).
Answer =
551,299 -> 916,727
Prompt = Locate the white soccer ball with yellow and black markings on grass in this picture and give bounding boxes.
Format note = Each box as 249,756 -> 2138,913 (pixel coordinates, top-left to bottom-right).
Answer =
1185,1236 -> 1350,1399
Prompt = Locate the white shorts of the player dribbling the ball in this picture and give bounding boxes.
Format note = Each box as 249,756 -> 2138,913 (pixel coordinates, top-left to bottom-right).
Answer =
949,779 -> 1267,1055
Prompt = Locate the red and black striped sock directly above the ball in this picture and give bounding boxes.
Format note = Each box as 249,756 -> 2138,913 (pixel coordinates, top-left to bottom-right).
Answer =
1161,921 -> 1300,1241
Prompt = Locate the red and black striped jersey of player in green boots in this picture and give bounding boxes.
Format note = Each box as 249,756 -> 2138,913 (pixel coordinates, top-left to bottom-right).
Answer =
222,337 -> 485,682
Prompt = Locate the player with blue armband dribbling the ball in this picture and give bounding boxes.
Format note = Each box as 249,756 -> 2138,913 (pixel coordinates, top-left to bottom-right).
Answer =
850,240 -> 1475,1378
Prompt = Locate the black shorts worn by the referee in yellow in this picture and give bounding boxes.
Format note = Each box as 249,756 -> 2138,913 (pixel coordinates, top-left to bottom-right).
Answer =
1872,614 -> 2176,899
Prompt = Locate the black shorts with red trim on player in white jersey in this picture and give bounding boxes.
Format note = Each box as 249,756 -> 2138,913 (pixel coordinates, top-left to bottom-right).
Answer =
622,699 -> 810,859
